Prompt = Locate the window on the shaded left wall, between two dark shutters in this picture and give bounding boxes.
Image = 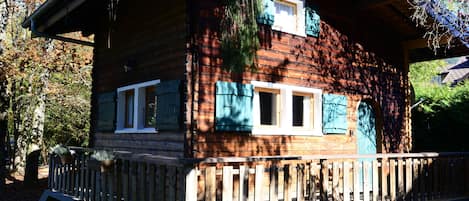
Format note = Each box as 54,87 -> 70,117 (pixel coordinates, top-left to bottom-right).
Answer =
115,80 -> 159,133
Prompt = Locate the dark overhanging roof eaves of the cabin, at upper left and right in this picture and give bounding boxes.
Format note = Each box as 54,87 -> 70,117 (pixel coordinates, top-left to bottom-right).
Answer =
23,0 -> 469,62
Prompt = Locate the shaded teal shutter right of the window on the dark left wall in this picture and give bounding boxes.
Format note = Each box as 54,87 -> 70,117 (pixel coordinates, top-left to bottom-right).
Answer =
155,80 -> 181,130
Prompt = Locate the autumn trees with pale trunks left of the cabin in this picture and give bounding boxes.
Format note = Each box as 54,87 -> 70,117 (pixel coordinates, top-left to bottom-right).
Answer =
0,0 -> 92,174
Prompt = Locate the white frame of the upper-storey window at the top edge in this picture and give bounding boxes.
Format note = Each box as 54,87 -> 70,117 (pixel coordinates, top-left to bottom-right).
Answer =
272,0 -> 306,37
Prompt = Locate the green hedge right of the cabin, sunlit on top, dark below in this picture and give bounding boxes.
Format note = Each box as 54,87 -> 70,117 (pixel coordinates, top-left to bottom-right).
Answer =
410,61 -> 469,151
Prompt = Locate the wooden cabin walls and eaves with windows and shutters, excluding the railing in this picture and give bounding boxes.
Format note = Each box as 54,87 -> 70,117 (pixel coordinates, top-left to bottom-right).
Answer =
23,0 -> 468,158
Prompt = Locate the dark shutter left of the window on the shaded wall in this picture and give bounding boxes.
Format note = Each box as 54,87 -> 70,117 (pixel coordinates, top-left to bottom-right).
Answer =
96,91 -> 116,132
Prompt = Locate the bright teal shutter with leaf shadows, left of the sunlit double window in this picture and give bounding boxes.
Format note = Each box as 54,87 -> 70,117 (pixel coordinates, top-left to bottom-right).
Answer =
215,82 -> 253,131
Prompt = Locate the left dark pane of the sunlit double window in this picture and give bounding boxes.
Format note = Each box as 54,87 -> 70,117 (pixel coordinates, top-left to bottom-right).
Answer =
259,92 -> 277,125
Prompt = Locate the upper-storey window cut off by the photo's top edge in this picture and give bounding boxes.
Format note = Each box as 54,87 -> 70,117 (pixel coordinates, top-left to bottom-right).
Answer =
272,0 -> 306,36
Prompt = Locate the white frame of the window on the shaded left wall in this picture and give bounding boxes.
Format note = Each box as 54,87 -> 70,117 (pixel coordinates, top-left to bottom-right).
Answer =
114,80 -> 160,133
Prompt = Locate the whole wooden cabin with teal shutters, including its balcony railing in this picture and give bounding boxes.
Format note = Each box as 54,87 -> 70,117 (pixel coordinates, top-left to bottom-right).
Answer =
23,0 -> 469,200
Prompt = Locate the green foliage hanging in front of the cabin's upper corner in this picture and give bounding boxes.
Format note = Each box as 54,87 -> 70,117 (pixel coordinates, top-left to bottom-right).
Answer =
221,0 -> 262,72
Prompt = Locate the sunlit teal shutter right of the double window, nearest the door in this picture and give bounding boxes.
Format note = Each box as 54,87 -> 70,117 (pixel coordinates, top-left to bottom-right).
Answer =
322,94 -> 348,134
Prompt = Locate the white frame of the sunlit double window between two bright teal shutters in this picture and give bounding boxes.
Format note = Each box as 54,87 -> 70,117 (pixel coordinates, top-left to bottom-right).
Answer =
251,81 -> 323,136
